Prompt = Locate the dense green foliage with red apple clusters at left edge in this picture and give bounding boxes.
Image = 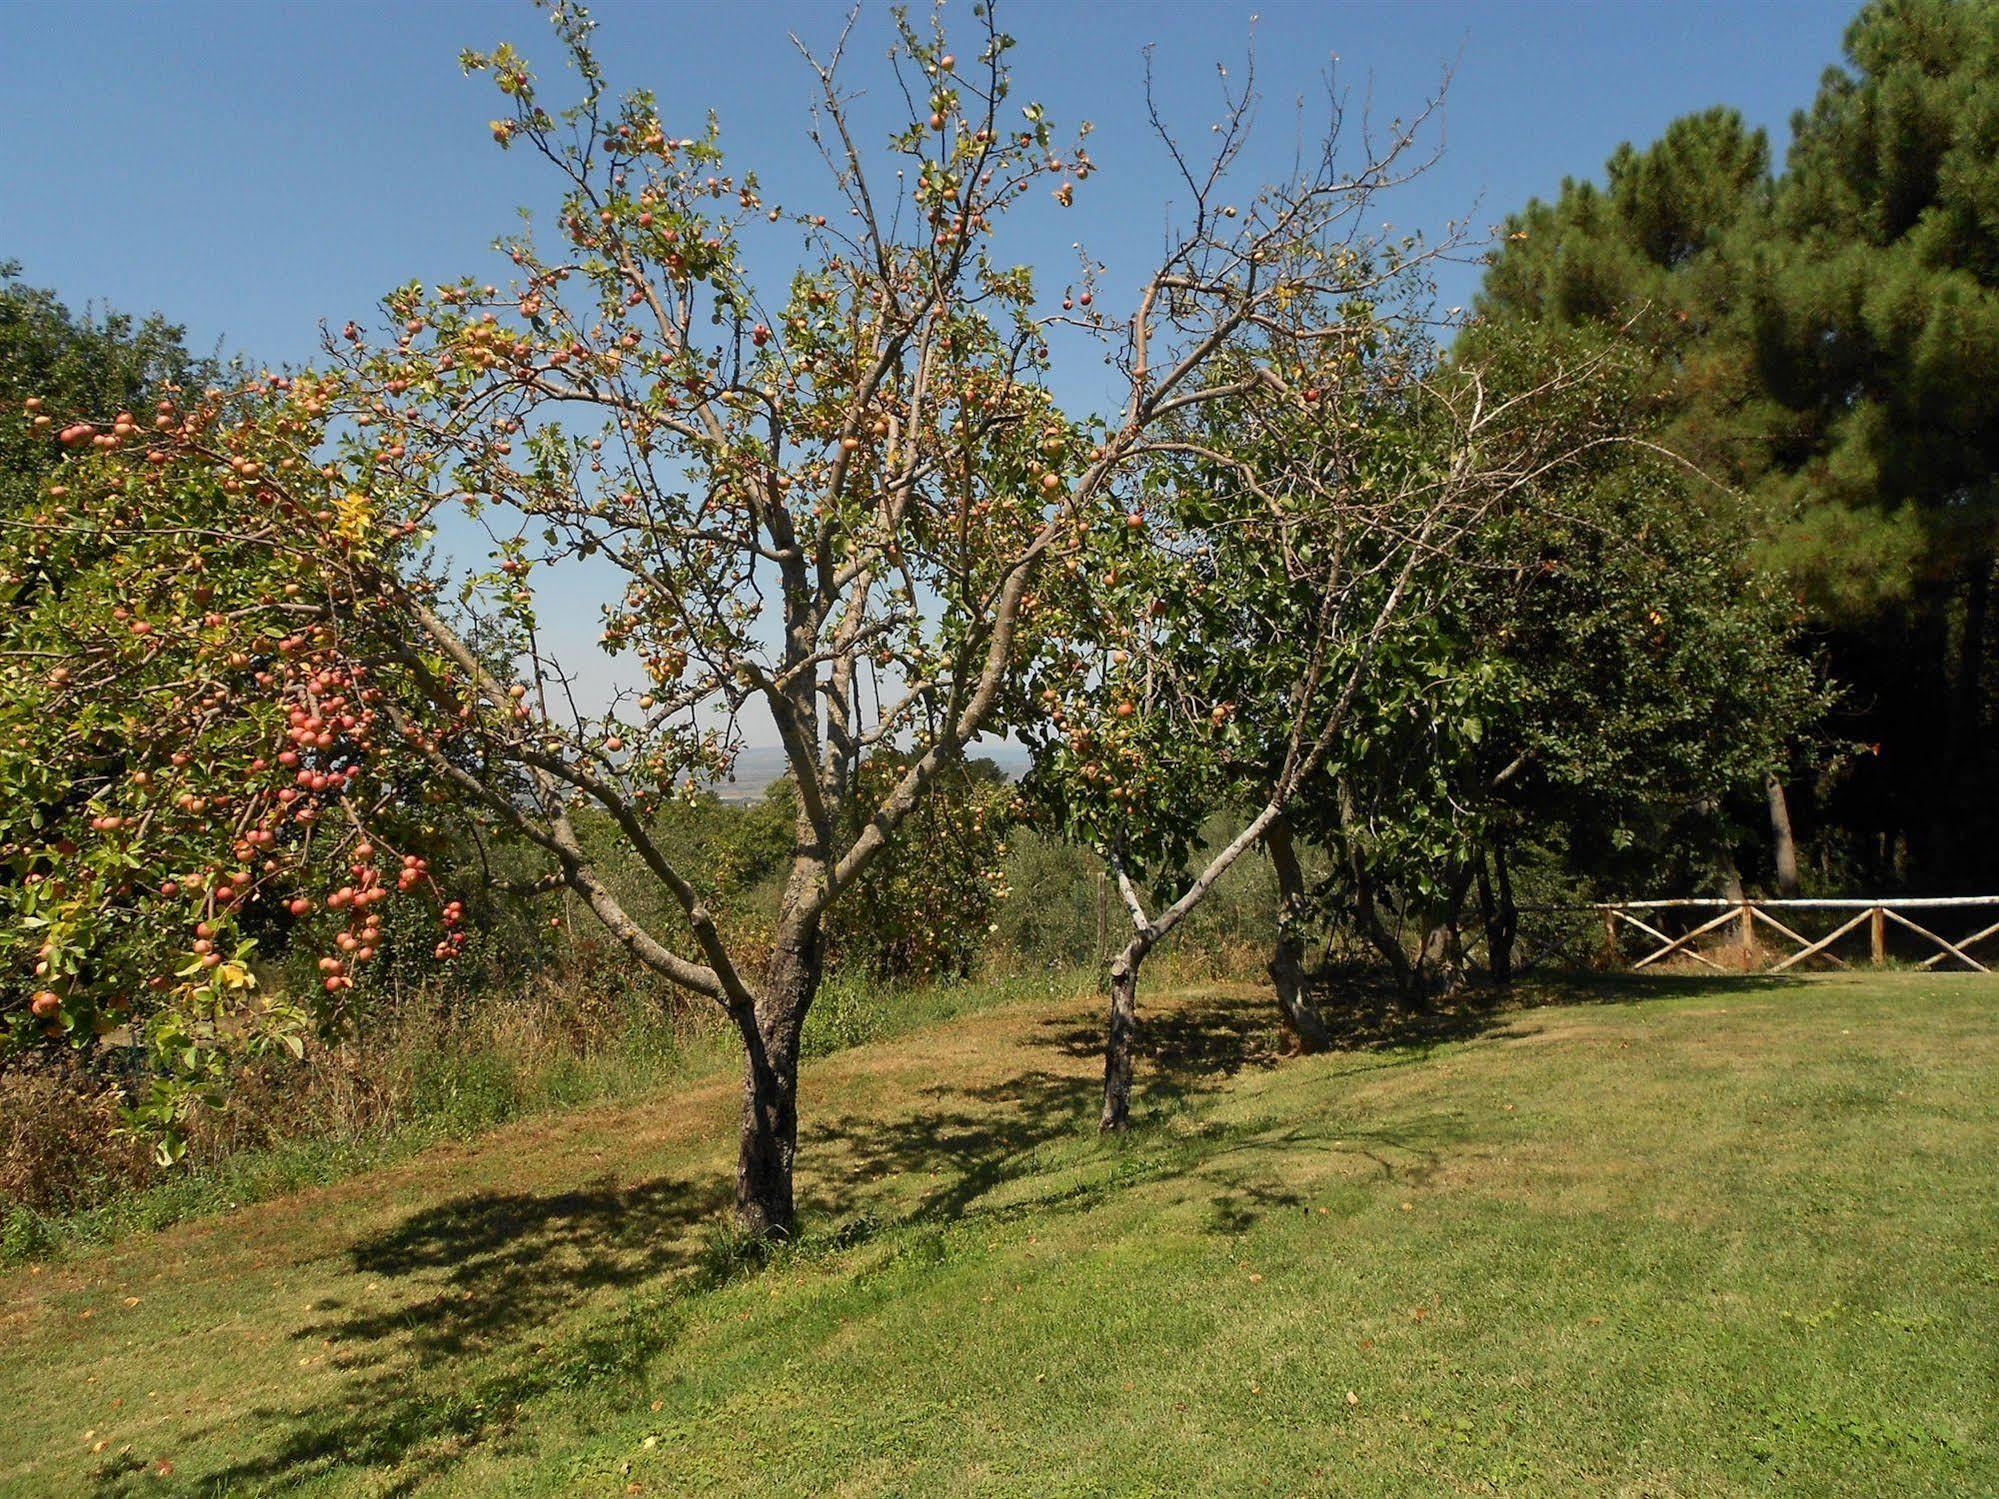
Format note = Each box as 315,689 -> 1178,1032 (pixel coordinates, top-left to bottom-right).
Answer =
0,376 -> 458,1157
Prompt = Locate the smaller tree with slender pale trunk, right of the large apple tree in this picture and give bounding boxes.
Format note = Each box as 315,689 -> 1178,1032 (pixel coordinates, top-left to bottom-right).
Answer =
1031,287 -> 1615,1129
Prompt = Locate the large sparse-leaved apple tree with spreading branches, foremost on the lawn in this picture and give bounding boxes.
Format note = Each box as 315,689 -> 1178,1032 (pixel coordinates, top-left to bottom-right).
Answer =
15,4 -> 1471,1237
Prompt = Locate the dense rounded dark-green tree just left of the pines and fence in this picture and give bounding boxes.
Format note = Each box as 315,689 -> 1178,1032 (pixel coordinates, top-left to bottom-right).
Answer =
1317,405 -> 1825,991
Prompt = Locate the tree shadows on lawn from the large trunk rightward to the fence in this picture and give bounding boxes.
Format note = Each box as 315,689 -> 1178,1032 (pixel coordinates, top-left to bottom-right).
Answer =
806,973 -> 1803,1241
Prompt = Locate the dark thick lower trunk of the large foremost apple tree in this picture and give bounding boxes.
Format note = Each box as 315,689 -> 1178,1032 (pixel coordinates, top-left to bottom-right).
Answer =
736,927 -> 824,1239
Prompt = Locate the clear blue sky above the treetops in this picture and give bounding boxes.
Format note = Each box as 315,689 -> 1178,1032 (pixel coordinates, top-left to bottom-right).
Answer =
0,0 -> 1853,747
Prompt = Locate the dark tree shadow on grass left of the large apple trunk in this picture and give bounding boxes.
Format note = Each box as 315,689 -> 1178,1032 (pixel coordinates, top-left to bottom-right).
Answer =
96,1177 -> 730,1495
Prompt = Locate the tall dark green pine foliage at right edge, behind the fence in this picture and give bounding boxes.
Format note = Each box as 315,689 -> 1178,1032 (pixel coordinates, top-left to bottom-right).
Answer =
1473,0 -> 1999,889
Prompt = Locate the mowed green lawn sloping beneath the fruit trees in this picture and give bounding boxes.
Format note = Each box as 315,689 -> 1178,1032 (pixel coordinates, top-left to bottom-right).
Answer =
0,973 -> 1999,1495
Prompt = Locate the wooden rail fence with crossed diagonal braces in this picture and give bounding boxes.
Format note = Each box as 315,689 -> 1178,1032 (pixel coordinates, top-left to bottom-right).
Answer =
1569,895 -> 1999,973
